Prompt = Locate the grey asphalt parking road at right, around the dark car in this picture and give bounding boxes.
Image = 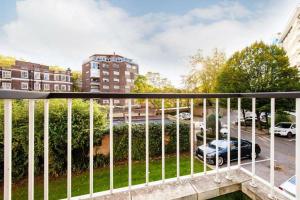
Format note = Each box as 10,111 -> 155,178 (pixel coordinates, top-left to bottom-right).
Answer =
198,111 -> 296,186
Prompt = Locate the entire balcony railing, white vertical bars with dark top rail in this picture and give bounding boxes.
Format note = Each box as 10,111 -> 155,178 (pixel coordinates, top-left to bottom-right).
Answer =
0,90 -> 300,200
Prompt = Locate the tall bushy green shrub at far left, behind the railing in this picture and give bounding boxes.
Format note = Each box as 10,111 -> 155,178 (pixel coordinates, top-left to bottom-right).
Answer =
0,100 -> 106,180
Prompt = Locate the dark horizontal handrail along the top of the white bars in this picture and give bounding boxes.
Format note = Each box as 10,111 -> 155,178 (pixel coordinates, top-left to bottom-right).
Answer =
0,90 -> 300,99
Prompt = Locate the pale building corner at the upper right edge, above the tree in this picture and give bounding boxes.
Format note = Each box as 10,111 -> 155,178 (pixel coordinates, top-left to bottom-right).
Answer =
279,7 -> 300,67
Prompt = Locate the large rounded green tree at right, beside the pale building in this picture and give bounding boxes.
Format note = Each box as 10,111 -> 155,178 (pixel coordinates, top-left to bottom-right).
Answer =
215,42 -> 300,127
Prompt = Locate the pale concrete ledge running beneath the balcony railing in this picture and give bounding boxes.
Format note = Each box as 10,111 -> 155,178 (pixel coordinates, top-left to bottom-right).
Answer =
86,169 -> 288,200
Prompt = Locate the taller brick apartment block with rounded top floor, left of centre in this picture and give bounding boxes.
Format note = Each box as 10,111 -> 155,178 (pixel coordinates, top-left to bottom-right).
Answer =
82,54 -> 139,105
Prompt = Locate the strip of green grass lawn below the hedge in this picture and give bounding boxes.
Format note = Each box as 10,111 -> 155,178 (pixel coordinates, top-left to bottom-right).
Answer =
0,154 -> 203,200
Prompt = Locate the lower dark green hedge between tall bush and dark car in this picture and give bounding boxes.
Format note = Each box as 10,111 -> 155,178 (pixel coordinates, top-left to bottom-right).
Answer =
109,122 -> 190,161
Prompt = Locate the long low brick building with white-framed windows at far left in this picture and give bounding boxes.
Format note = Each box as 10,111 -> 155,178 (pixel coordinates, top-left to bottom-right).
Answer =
0,60 -> 72,92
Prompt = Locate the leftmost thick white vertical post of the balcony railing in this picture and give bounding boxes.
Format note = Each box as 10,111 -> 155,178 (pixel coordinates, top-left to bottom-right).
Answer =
3,99 -> 12,200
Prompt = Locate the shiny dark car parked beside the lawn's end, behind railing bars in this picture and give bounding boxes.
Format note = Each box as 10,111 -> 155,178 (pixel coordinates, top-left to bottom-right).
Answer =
196,137 -> 261,166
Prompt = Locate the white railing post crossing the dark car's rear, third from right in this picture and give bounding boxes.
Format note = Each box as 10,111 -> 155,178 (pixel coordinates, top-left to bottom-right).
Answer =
250,98 -> 259,187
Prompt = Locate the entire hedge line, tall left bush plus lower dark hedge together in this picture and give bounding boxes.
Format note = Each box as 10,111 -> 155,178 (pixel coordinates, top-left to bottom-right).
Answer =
0,100 -> 189,181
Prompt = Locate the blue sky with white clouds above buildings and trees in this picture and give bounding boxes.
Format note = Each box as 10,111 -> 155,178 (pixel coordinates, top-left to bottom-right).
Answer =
0,0 -> 300,87
